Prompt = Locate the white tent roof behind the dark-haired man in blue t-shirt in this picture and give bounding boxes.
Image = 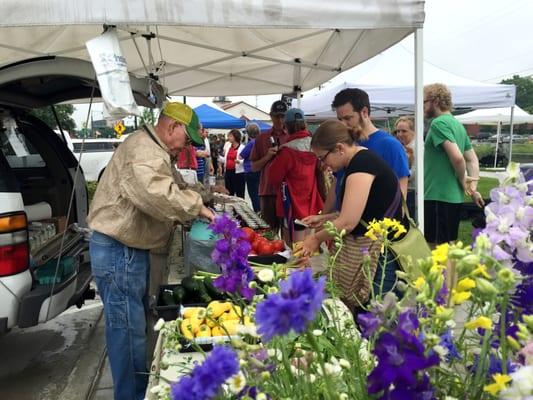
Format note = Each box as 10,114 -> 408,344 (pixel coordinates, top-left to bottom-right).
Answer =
294,43 -> 516,118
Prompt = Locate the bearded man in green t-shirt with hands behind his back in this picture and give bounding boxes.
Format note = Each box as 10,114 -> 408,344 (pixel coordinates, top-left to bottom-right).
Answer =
424,83 -> 483,244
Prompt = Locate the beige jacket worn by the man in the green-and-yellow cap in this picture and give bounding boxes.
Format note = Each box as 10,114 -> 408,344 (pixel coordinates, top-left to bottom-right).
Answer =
88,127 -> 203,249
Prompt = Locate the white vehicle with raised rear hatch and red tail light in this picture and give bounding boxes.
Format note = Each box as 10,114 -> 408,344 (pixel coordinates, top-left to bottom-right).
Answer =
0,56 -> 162,333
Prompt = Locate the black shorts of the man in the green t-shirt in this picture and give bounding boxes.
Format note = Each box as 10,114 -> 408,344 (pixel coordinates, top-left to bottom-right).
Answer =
424,200 -> 461,244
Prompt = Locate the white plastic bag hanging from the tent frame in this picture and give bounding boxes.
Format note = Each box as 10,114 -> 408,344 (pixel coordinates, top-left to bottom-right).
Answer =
85,28 -> 140,120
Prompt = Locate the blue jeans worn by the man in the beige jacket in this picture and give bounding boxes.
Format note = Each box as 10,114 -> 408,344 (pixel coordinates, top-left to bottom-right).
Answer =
89,231 -> 150,400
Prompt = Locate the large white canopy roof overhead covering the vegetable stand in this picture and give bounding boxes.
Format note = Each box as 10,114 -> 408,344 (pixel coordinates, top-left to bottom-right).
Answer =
0,0 -> 424,96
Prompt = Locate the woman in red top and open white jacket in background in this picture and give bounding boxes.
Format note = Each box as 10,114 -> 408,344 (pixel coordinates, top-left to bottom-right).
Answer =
220,129 -> 246,199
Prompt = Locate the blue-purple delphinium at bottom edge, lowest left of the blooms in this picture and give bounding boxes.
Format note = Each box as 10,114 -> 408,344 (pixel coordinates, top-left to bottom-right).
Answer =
171,346 -> 239,400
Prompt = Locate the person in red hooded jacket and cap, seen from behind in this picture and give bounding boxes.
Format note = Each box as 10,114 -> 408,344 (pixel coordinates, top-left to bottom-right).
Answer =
268,108 -> 324,243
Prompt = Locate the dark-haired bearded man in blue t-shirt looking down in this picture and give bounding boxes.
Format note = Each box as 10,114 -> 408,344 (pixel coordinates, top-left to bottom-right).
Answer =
324,88 -> 410,213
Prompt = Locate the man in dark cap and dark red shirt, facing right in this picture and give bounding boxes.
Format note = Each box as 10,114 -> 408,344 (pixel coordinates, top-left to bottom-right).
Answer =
250,100 -> 289,231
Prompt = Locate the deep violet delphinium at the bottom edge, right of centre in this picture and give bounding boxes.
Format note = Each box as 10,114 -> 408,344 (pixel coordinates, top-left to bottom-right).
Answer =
367,310 -> 440,399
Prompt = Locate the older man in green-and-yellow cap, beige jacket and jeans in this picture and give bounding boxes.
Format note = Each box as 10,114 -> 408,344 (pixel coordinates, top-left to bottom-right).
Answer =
88,103 -> 214,400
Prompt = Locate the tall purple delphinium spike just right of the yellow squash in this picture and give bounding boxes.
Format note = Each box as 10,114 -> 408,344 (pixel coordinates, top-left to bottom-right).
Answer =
210,214 -> 255,300
